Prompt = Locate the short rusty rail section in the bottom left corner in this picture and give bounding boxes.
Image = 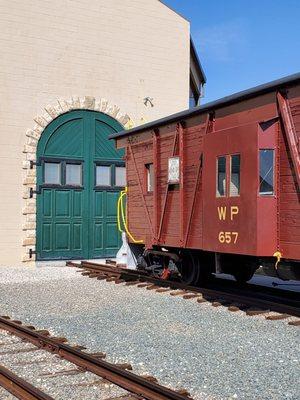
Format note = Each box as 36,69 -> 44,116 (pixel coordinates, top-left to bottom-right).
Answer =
0,365 -> 54,400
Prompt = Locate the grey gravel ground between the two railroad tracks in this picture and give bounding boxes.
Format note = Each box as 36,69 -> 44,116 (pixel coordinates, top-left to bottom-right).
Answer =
0,267 -> 300,400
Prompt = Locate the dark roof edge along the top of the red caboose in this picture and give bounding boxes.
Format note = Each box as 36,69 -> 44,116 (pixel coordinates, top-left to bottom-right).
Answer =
109,73 -> 300,139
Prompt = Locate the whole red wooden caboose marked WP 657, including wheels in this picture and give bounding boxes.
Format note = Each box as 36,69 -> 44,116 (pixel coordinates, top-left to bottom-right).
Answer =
111,74 -> 300,284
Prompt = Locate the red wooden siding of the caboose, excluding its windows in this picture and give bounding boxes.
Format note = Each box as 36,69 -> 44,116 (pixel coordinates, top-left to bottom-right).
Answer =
111,74 -> 300,260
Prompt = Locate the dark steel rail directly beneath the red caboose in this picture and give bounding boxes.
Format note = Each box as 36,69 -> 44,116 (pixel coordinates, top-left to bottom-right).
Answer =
67,261 -> 300,317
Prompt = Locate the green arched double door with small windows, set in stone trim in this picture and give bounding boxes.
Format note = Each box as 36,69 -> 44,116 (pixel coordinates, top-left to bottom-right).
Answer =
37,111 -> 125,260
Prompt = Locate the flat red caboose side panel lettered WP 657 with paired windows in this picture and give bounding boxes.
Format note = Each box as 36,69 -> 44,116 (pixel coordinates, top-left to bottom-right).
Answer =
203,124 -> 258,254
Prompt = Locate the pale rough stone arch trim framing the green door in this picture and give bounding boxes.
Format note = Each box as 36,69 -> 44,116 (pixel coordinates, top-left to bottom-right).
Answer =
22,96 -> 132,263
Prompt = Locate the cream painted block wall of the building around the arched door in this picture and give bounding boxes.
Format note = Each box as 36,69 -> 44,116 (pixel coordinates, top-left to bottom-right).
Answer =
0,0 -> 189,265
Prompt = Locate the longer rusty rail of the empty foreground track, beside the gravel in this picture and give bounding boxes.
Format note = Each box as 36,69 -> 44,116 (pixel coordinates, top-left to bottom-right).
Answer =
0,317 -> 187,400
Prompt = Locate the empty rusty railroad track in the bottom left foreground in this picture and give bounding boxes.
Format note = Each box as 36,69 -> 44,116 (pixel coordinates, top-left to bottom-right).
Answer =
0,316 -> 191,400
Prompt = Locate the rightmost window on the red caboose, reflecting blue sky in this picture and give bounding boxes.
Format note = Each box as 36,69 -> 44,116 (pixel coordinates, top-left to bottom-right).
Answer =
259,149 -> 274,196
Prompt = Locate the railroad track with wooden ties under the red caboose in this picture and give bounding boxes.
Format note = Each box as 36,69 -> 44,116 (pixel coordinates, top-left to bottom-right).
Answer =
66,261 -> 300,326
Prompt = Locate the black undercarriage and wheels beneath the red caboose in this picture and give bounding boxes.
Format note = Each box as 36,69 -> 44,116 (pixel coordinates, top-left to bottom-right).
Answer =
130,244 -> 300,286
